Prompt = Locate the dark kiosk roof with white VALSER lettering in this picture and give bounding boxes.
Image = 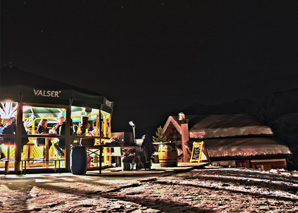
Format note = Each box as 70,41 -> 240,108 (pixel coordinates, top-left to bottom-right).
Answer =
0,66 -> 114,112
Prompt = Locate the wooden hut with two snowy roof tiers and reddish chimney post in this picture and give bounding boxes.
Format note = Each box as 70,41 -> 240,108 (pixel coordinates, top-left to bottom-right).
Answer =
163,114 -> 291,169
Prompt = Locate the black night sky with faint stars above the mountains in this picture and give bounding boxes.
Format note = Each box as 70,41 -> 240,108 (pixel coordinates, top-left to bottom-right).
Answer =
1,0 -> 298,130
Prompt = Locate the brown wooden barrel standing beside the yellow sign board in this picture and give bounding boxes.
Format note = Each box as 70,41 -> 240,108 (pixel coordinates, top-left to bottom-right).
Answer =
158,143 -> 178,167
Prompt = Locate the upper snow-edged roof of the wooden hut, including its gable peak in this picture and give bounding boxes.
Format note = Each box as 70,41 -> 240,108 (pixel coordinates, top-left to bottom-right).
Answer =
163,114 -> 273,139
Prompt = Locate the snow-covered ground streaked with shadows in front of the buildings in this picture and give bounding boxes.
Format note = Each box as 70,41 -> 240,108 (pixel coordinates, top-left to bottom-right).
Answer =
0,168 -> 298,212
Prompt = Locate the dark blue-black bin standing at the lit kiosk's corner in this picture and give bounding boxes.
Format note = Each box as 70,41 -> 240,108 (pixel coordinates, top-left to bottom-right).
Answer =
70,146 -> 87,175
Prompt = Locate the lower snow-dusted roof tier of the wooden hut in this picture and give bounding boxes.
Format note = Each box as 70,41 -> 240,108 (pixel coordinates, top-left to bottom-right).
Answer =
204,137 -> 292,158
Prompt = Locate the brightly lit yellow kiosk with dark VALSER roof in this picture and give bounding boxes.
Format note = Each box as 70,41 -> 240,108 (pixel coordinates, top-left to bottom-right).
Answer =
0,66 -> 114,173
